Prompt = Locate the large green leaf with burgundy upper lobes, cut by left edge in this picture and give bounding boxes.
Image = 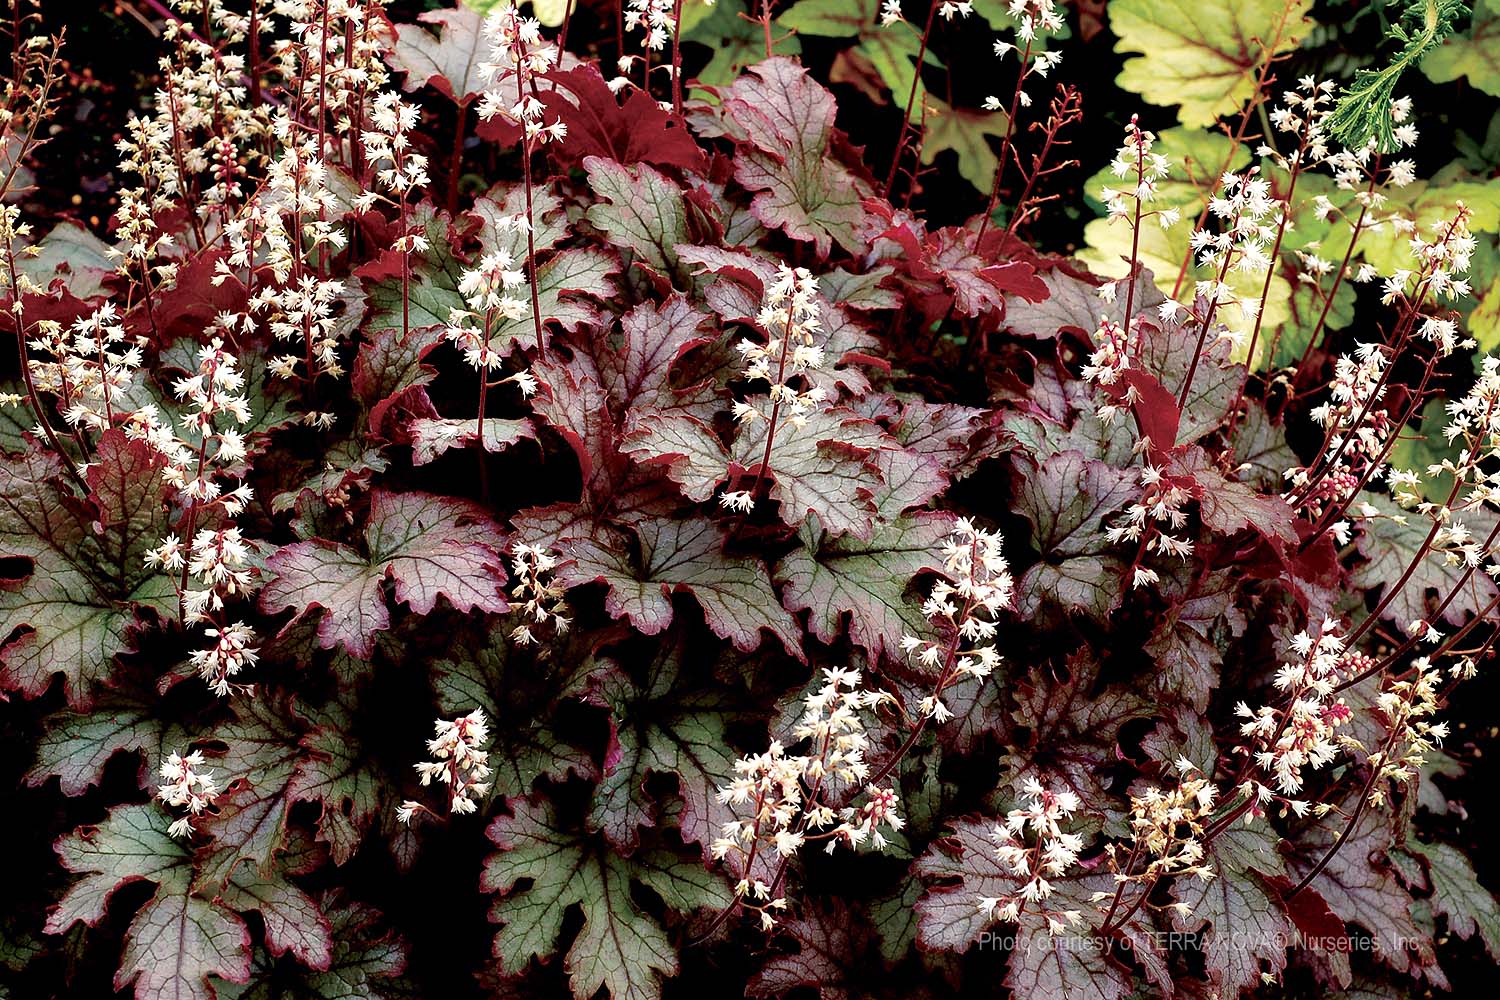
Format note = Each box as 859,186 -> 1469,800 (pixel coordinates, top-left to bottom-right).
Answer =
0,430 -> 177,709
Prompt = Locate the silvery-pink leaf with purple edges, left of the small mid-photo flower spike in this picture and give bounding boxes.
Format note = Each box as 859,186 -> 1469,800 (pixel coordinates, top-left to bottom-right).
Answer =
261,490 -> 510,657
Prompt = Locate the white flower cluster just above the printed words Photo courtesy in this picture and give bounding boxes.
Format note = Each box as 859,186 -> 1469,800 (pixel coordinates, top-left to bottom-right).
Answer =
977,777 -> 1083,934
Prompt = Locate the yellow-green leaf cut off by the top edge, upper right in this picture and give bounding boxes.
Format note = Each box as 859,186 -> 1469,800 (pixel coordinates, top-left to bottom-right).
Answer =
1109,0 -> 1313,126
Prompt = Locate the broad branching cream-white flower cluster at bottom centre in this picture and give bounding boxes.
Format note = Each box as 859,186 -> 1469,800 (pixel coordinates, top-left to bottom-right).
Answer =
711,667 -> 905,930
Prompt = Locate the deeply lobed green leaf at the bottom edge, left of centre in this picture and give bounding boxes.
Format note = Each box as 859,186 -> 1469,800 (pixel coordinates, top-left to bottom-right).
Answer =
480,799 -> 731,1000
